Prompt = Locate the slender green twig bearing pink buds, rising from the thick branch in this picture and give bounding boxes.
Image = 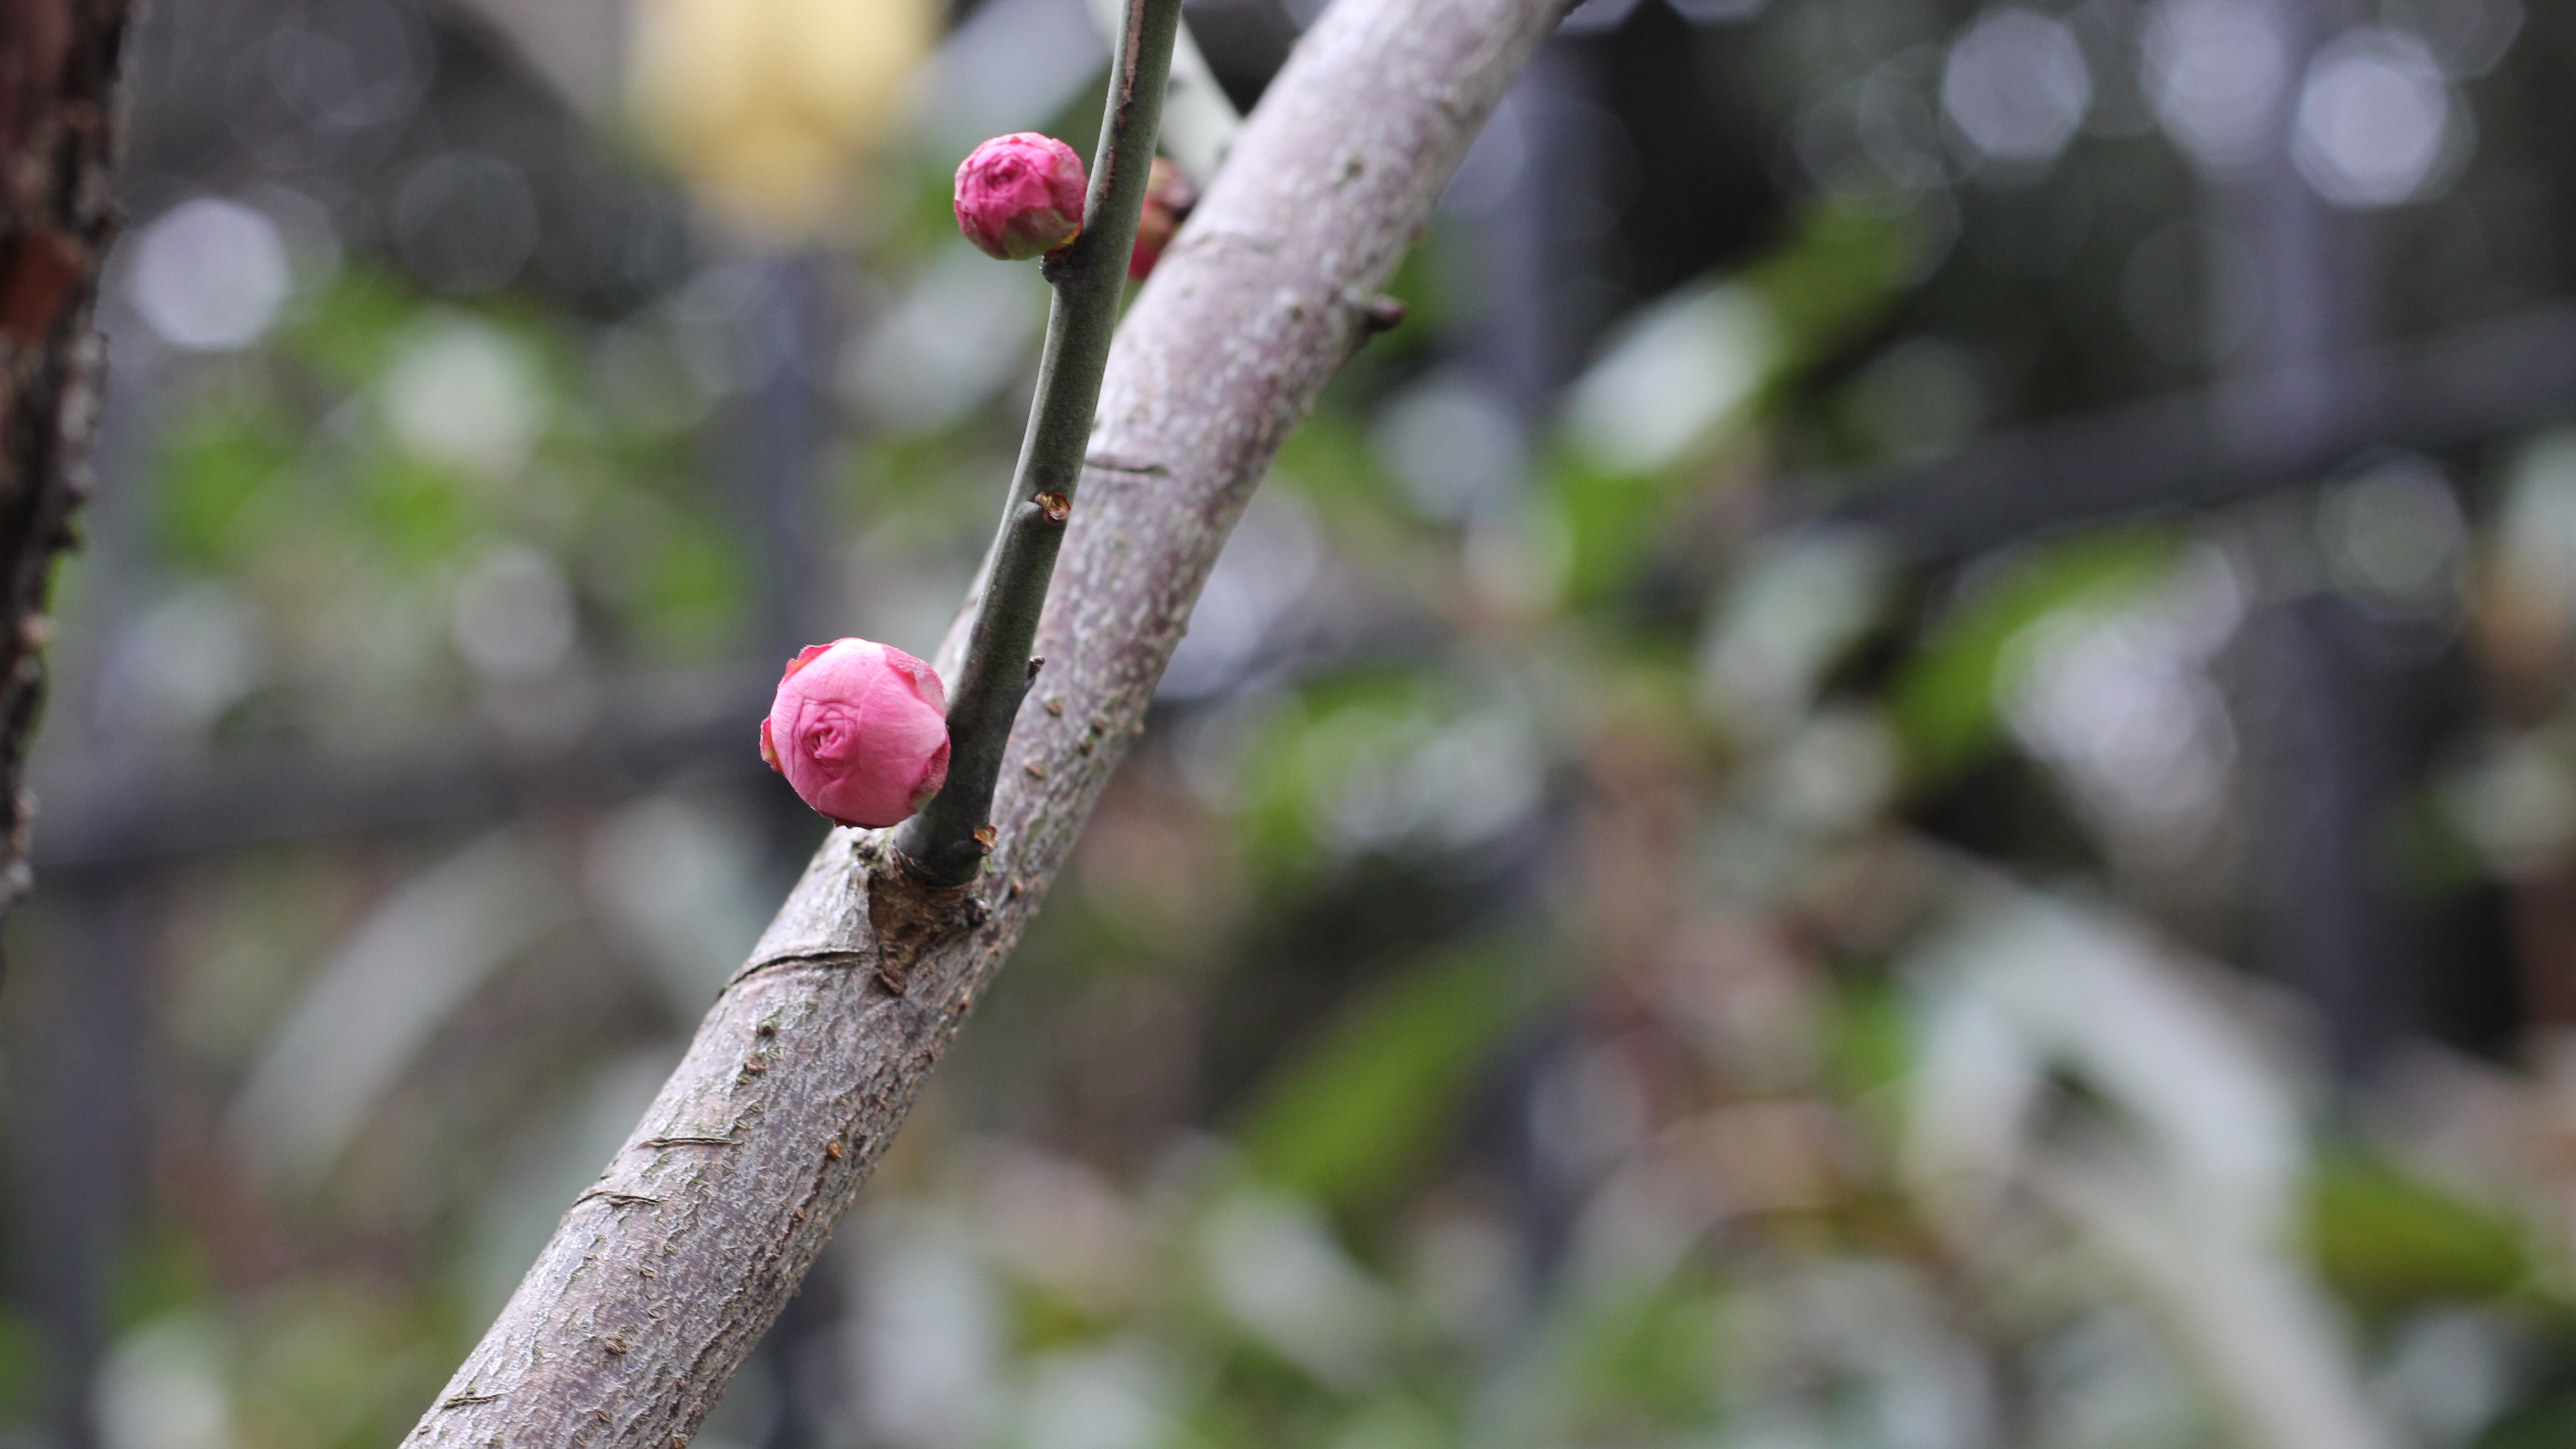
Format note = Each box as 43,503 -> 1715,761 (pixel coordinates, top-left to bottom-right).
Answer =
894,0 -> 1180,887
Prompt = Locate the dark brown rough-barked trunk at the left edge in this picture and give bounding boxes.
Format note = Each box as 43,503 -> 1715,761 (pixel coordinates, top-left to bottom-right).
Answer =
0,0 -> 126,915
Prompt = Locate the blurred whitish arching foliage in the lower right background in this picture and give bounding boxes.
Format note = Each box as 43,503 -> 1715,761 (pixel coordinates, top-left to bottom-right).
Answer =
1904,879 -> 2396,1449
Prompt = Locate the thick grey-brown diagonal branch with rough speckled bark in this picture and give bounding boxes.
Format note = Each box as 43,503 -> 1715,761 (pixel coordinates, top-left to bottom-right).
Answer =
410,0 -> 1564,1449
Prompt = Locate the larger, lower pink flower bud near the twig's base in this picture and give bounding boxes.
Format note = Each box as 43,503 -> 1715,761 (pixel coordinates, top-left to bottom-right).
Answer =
760,639 -> 948,828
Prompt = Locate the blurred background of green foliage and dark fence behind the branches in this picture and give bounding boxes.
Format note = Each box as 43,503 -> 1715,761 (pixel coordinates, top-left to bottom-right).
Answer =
0,0 -> 2576,1449
